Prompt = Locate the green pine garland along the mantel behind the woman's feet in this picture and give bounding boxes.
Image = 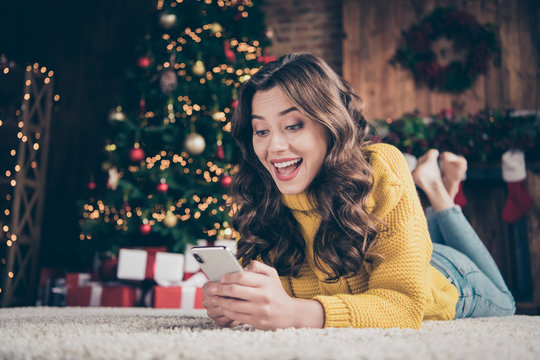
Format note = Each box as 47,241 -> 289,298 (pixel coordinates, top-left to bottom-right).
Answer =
372,110 -> 540,162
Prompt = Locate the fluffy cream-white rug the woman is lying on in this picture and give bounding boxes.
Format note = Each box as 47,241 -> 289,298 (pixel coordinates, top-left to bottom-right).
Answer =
0,307 -> 540,360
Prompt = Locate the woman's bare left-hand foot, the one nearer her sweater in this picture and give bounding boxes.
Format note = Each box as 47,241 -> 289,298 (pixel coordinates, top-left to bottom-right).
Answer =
412,149 -> 454,211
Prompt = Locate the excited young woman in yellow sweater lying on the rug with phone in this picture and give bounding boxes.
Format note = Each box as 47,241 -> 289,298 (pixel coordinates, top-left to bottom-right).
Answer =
203,54 -> 514,329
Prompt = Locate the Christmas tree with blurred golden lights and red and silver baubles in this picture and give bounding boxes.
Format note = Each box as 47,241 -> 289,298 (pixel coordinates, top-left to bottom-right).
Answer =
80,0 -> 271,258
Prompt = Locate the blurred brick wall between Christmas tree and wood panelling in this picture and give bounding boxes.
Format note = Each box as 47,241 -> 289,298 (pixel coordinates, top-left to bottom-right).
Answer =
263,0 -> 343,74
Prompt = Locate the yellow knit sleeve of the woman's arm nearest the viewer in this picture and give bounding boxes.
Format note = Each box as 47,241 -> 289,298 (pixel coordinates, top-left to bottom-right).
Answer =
314,144 -> 432,329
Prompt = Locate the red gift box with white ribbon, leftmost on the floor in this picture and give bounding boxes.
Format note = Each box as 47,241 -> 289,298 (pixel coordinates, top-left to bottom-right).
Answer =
66,283 -> 141,307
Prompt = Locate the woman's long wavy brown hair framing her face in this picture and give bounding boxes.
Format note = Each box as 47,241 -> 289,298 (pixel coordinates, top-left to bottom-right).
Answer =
231,53 -> 381,282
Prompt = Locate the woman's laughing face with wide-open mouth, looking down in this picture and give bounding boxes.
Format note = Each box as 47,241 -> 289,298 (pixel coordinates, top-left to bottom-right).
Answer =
251,86 -> 328,195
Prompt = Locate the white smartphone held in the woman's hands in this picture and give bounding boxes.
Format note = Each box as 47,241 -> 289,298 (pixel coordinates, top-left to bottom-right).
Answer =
191,246 -> 243,281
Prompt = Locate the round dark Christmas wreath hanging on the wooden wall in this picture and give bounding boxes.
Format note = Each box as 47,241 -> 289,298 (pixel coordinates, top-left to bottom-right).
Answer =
392,8 -> 500,93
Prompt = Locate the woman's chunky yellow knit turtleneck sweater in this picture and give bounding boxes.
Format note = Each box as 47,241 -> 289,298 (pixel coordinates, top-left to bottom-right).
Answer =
281,144 -> 459,329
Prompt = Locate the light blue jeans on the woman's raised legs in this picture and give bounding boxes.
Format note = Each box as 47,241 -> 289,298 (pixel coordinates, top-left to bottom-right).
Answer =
426,206 -> 516,319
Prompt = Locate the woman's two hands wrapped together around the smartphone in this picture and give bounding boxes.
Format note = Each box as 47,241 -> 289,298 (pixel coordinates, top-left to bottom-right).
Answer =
203,261 -> 324,330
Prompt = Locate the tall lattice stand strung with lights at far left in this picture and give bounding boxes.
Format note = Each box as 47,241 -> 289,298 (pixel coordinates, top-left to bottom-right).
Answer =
0,63 -> 53,307
